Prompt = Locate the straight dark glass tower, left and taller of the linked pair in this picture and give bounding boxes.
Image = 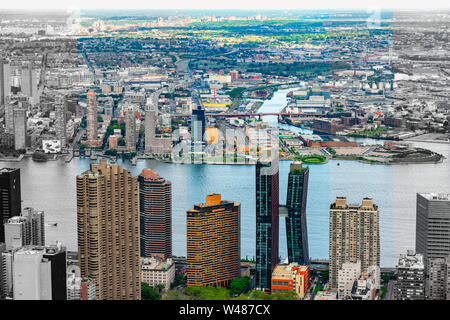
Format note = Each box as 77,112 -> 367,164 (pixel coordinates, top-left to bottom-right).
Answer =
256,159 -> 279,291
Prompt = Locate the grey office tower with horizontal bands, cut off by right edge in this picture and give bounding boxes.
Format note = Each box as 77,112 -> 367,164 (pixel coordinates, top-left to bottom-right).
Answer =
416,193 -> 450,265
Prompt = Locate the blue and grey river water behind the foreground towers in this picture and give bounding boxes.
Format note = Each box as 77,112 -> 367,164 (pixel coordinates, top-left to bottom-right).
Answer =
0,89 -> 450,267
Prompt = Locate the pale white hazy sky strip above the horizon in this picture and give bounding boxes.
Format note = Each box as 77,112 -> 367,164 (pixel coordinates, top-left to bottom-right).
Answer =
0,0 -> 450,10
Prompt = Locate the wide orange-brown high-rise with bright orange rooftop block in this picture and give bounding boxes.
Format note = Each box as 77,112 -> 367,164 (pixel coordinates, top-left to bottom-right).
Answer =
186,194 -> 241,286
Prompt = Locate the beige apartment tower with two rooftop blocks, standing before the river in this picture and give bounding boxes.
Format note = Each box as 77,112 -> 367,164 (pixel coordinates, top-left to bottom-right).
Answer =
329,197 -> 380,289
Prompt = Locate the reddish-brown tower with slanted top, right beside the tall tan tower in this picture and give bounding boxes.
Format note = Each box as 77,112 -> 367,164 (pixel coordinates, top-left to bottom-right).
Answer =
138,169 -> 172,260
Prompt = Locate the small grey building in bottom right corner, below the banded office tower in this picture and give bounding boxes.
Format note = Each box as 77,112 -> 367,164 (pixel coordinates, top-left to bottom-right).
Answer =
425,255 -> 450,300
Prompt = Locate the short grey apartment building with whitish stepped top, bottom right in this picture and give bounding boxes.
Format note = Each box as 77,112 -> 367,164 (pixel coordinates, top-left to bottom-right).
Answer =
394,250 -> 425,300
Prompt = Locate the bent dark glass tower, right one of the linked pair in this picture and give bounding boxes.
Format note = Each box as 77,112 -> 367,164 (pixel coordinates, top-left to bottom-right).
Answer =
286,162 -> 309,265
